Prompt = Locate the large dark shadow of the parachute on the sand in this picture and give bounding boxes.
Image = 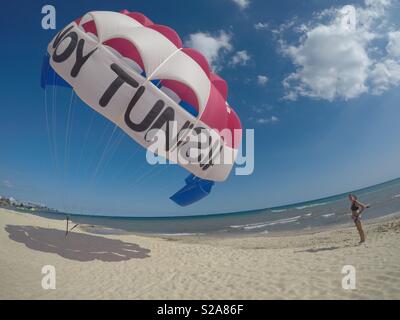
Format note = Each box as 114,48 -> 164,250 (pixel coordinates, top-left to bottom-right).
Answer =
5,225 -> 150,262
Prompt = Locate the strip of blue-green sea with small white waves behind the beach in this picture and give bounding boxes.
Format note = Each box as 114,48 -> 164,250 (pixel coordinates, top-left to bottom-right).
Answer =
10,179 -> 400,236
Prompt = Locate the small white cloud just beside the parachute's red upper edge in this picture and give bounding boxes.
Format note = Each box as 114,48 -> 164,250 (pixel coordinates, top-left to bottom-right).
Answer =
185,30 -> 233,70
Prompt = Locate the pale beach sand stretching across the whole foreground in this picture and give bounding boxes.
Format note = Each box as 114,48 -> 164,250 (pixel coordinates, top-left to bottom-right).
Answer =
0,209 -> 400,299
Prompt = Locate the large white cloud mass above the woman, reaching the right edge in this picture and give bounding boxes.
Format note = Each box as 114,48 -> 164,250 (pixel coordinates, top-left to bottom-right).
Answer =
279,0 -> 400,101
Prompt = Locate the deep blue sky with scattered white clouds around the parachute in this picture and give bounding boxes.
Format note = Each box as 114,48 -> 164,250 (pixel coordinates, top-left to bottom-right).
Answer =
0,0 -> 400,216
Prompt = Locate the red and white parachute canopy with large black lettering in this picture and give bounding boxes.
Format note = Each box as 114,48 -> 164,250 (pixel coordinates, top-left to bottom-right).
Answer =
42,10 -> 241,204
